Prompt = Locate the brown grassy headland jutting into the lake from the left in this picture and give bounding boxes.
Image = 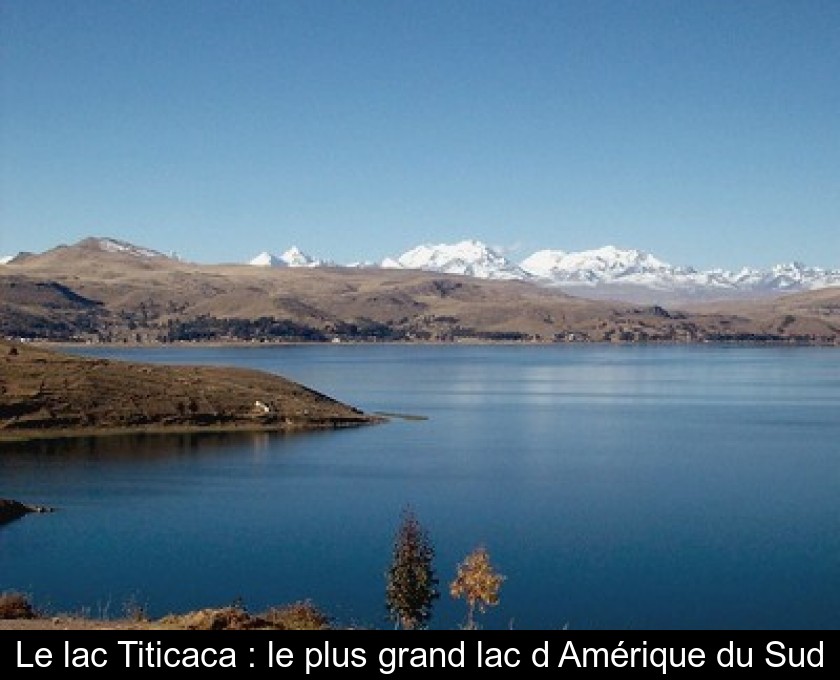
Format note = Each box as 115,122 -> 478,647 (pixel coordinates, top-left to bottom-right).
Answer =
0,341 -> 381,438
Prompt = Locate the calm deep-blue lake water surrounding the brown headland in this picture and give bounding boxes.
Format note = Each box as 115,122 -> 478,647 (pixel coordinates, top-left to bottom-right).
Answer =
0,345 -> 840,630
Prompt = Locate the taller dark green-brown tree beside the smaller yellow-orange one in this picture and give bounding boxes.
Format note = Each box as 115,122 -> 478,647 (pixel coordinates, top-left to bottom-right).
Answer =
385,508 -> 440,630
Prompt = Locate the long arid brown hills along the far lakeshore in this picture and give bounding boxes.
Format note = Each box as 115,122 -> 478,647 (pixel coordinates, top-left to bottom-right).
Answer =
0,238 -> 840,345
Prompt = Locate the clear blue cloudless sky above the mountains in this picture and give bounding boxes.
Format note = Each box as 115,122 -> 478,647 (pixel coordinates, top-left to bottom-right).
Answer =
0,0 -> 840,268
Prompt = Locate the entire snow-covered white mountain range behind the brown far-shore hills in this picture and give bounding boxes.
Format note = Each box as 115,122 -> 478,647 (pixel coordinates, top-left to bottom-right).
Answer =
240,240 -> 840,303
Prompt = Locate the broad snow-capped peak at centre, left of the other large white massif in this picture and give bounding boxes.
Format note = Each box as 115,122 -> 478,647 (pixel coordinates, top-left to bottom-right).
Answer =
381,240 -> 531,279
